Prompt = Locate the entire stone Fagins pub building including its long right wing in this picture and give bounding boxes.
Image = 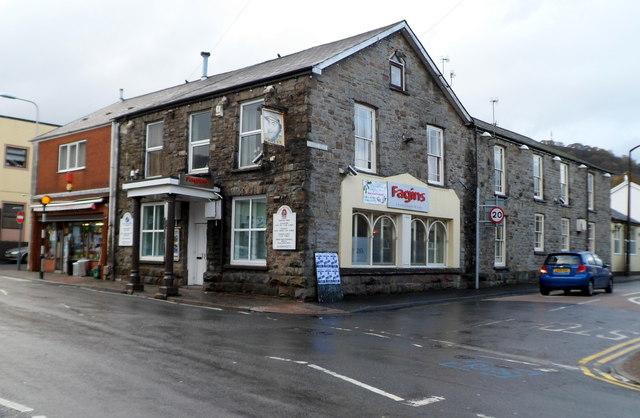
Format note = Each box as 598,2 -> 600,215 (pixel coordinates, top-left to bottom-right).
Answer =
50,21 -> 610,299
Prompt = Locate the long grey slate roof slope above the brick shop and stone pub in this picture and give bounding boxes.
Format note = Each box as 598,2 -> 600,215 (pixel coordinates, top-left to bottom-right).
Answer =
35,21 -> 440,141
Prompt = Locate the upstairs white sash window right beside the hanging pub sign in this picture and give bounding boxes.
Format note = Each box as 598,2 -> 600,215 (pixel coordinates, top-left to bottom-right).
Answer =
238,100 -> 264,168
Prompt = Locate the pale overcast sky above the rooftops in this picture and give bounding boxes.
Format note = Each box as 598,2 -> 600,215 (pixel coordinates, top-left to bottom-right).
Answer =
0,0 -> 640,159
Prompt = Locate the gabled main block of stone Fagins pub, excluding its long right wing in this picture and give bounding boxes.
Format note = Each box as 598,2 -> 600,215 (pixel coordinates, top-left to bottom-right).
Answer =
111,22 -> 474,299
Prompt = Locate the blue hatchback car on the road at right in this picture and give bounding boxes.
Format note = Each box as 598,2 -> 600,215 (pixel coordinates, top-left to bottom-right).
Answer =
540,251 -> 613,296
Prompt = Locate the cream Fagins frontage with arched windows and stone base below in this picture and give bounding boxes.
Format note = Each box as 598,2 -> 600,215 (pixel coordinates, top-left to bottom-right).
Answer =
339,173 -> 461,293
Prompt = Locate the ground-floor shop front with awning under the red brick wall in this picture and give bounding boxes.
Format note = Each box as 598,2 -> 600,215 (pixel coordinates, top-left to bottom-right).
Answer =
31,198 -> 108,278
